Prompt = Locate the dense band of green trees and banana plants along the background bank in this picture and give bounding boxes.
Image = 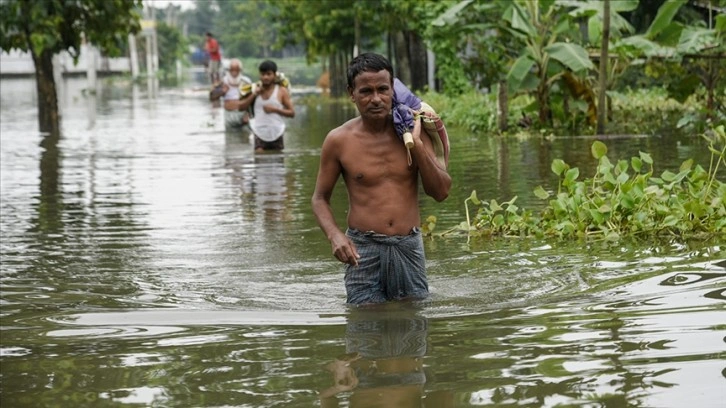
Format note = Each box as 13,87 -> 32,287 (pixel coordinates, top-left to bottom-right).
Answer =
169,0 -> 726,133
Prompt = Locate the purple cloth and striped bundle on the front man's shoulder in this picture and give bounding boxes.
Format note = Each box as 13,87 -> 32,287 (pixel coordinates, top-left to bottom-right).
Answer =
393,78 -> 449,168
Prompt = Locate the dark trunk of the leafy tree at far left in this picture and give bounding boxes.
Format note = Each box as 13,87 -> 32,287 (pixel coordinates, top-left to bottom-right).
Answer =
32,50 -> 60,135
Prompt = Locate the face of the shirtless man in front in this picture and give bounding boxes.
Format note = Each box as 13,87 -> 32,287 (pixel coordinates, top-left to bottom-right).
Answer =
348,69 -> 393,119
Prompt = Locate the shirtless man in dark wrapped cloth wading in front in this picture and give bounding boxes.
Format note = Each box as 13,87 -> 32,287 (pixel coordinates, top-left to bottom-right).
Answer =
312,53 -> 451,304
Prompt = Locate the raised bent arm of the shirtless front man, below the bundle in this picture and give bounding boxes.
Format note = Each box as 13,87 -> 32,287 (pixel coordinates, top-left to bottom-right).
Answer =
411,119 -> 451,201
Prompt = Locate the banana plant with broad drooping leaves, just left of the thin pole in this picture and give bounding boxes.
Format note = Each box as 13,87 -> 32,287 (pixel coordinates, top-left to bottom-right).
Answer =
504,0 -> 594,124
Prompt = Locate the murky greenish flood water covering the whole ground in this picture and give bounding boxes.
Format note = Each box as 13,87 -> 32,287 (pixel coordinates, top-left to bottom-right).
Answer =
0,74 -> 726,408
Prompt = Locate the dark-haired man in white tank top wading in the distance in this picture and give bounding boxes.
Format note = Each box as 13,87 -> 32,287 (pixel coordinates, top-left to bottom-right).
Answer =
241,60 -> 295,152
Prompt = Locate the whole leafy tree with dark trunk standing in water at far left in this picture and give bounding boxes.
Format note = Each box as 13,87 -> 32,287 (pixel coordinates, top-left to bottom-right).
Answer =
0,0 -> 141,134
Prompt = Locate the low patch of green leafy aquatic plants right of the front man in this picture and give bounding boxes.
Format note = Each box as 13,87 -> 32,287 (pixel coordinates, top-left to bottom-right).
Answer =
436,125 -> 726,240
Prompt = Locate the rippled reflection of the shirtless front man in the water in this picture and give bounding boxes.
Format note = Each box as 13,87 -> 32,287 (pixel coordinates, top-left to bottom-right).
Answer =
320,304 -> 453,408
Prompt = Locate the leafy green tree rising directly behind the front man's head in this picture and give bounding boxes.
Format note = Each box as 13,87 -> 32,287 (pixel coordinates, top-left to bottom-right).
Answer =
274,0 -> 444,96
